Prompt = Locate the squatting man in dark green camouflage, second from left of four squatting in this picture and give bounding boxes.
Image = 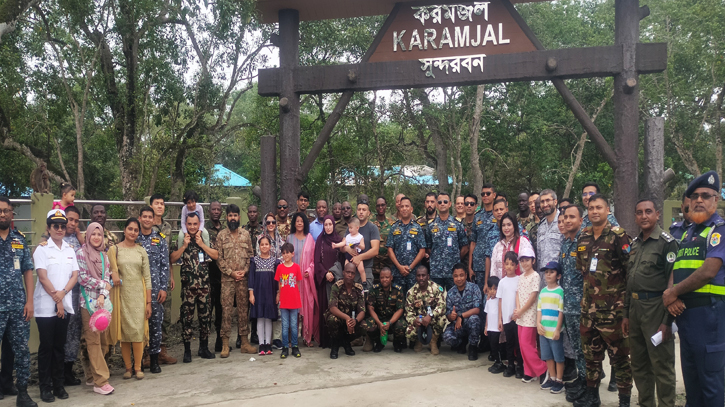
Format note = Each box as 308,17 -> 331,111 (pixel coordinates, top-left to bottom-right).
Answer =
363,267 -> 406,353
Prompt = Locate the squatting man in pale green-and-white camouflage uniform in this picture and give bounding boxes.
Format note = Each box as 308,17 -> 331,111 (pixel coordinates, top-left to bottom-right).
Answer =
405,265 -> 446,355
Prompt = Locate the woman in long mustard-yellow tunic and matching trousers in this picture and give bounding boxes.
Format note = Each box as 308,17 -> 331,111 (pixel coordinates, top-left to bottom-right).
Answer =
108,218 -> 151,380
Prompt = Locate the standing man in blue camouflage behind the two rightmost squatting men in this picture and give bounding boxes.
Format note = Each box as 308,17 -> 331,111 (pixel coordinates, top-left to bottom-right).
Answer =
425,192 -> 468,290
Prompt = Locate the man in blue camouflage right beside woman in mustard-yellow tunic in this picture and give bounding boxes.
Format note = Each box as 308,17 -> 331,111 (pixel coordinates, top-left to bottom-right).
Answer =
136,206 -> 169,373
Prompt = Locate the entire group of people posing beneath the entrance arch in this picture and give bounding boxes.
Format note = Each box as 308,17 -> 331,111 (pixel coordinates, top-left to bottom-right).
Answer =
0,172 -> 725,407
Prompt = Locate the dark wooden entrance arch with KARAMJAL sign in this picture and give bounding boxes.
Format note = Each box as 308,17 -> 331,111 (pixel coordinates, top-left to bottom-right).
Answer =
257,0 -> 667,230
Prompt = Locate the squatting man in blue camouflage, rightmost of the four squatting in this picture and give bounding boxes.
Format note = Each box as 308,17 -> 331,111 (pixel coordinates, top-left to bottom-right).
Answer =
443,263 -> 481,361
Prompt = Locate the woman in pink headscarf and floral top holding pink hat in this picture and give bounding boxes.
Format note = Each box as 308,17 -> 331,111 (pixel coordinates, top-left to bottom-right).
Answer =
76,222 -> 114,395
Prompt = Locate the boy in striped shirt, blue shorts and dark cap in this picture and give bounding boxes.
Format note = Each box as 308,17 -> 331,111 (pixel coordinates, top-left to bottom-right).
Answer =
536,261 -> 564,394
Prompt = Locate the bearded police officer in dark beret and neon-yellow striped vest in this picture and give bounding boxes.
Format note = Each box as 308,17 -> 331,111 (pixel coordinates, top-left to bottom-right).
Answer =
662,171 -> 725,407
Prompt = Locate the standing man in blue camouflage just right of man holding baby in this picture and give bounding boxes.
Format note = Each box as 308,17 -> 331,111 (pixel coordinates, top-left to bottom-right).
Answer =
387,196 -> 427,295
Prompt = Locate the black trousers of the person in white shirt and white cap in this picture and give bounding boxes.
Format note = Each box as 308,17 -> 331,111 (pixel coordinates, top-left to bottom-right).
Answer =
35,315 -> 68,390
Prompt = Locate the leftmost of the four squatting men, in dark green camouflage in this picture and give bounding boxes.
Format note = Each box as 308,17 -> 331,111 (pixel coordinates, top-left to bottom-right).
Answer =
325,263 -> 368,359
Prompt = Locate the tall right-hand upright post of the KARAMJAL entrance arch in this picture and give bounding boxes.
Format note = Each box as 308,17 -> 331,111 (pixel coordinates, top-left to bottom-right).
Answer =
614,0 -> 639,234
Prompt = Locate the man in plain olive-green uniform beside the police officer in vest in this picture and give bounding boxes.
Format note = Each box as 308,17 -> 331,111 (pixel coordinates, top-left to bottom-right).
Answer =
624,200 -> 679,407
